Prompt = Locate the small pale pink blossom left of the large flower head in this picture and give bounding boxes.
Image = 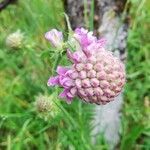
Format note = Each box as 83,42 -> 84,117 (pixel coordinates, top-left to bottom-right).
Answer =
45,29 -> 63,48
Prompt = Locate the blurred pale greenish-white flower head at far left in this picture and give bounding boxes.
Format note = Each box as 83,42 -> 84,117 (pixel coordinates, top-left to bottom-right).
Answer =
6,30 -> 24,48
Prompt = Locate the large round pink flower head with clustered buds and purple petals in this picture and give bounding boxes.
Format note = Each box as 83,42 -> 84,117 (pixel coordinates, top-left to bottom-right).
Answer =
45,28 -> 125,104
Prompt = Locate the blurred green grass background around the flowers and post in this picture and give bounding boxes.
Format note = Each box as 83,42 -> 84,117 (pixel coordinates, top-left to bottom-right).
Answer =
0,0 -> 150,150
